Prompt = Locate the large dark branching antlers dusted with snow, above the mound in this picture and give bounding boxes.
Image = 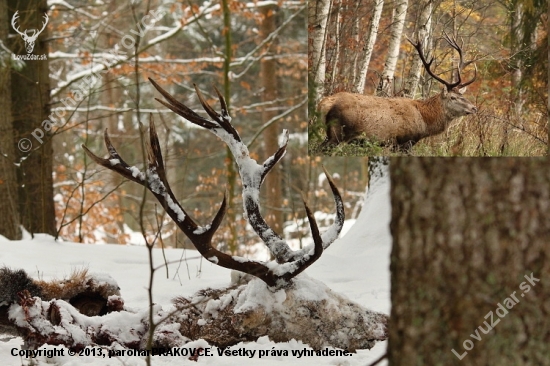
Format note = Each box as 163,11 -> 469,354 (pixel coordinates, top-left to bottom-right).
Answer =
82,79 -> 344,288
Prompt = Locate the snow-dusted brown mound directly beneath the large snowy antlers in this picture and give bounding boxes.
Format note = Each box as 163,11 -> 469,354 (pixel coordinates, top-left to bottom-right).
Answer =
173,273 -> 388,352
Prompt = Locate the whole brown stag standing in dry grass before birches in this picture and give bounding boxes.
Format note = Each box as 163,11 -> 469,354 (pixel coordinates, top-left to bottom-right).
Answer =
318,34 -> 477,150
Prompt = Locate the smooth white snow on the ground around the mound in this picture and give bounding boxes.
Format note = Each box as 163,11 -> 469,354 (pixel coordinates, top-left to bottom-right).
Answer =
0,171 -> 391,366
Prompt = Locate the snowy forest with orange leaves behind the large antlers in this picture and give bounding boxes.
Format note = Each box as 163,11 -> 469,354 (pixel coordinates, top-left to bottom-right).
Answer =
0,0 -> 374,254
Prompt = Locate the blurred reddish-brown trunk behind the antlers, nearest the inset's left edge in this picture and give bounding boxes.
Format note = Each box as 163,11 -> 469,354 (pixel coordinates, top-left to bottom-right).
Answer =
260,6 -> 284,233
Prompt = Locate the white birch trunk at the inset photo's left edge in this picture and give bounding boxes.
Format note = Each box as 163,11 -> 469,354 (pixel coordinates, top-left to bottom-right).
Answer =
308,0 -> 331,104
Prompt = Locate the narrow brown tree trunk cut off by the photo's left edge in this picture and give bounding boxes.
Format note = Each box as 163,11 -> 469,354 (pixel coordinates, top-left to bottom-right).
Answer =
0,1 -> 21,240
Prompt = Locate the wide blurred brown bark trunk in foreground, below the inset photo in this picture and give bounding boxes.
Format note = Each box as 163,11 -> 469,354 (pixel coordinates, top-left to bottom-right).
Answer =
388,158 -> 550,365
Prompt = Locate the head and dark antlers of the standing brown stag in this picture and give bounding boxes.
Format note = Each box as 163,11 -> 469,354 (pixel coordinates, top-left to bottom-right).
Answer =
409,34 -> 477,119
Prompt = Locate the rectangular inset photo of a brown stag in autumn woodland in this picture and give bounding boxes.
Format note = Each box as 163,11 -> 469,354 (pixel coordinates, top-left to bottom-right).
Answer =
308,0 -> 548,156
